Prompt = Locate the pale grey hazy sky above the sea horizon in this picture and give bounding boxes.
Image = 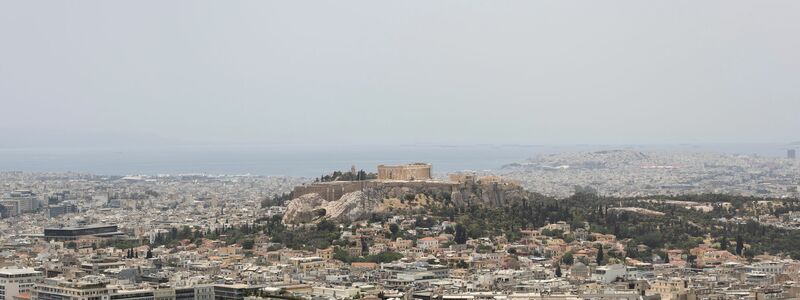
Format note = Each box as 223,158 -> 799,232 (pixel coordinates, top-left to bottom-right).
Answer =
0,0 -> 800,147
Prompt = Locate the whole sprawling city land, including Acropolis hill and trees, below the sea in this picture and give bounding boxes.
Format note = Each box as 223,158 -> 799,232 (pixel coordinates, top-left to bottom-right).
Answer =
0,150 -> 800,300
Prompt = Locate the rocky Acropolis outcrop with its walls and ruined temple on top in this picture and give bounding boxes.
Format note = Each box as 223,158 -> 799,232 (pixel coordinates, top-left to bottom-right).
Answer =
284,163 -> 527,224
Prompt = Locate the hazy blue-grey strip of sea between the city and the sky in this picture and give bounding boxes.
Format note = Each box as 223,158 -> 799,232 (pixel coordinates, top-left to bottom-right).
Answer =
0,144 -> 797,178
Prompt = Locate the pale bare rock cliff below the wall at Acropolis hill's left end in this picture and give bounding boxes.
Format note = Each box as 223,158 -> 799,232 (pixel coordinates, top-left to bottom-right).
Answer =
283,191 -> 380,224
